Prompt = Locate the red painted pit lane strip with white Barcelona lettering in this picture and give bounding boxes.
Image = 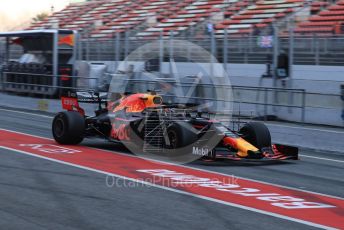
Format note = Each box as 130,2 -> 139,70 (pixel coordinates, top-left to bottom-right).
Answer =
0,129 -> 344,229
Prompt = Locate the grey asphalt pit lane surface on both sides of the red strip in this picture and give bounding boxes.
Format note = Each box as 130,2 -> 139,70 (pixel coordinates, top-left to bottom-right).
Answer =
0,109 -> 344,229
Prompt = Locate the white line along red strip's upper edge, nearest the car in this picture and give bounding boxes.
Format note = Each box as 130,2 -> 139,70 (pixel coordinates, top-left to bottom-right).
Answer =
0,128 -> 344,200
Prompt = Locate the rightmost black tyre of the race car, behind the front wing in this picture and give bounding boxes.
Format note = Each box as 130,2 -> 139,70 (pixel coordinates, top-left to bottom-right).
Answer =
239,122 -> 271,150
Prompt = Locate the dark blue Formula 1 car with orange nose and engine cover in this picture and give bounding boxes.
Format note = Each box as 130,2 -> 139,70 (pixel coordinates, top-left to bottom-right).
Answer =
52,92 -> 298,160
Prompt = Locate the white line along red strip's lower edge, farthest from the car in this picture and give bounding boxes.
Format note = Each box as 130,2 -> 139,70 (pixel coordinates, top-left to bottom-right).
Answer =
0,146 -> 335,230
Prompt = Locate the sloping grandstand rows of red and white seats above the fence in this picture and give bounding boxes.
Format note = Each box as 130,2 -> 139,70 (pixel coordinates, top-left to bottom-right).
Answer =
28,0 -> 344,40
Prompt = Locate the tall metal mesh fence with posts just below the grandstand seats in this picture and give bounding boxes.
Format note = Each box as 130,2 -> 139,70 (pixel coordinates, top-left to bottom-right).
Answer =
78,34 -> 344,66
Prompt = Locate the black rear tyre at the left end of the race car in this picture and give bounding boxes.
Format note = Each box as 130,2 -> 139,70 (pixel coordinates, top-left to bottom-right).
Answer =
52,111 -> 85,145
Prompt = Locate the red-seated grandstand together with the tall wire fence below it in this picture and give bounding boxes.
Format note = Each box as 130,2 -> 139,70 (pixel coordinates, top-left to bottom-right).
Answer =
20,0 -> 344,66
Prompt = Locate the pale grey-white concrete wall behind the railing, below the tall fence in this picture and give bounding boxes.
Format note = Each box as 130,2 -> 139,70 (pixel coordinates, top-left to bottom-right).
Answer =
97,62 -> 344,127
